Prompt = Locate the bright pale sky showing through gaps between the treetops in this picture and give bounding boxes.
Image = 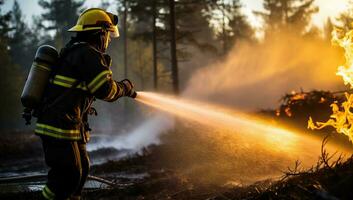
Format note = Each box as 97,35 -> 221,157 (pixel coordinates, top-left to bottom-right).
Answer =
0,0 -> 350,28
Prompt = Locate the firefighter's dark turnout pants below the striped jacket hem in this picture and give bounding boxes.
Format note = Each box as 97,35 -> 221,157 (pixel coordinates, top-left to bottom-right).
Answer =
41,136 -> 89,200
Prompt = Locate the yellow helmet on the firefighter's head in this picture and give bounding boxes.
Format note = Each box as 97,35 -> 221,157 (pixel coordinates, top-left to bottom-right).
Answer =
68,8 -> 119,37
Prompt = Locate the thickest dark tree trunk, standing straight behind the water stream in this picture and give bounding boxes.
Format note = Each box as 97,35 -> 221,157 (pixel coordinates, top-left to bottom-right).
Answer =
169,0 -> 179,94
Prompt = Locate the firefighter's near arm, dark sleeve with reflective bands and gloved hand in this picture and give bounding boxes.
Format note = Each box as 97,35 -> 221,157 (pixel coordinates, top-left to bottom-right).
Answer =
79,48 -> 136,102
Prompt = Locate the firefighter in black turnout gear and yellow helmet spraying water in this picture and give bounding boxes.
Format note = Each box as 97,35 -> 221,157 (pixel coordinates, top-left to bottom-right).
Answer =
35,8 -> 136,199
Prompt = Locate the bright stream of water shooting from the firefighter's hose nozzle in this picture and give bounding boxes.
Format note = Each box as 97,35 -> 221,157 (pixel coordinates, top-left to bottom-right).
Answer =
136,92 -> 340,153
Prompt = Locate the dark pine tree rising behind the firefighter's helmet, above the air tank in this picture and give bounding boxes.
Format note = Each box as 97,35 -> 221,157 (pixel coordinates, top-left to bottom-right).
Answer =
38,0 -> 84,48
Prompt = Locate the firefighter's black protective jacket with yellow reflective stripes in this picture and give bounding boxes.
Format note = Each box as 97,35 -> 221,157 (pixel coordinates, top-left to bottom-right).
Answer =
35,42 -> 126,141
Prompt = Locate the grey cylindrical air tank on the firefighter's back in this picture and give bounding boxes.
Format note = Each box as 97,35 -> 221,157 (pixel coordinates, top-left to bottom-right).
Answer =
21,45 -> 59,108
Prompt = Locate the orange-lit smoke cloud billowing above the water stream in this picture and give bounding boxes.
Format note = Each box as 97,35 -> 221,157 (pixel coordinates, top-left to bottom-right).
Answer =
184,33 -> 343,110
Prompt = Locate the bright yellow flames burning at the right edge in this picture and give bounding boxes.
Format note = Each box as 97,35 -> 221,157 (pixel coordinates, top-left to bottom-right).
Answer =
308,29 -> 353,143
